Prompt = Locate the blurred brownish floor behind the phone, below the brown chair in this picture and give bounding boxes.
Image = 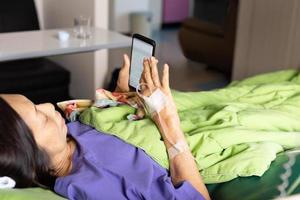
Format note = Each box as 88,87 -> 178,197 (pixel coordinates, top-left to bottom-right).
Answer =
108,27 -> 228,91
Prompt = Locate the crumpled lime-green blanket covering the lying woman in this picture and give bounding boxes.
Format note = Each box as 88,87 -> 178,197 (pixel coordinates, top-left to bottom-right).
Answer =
80,70 -> 300,183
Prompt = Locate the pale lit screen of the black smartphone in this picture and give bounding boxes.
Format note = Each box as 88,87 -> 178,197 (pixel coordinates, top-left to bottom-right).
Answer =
129,38 -> 153,88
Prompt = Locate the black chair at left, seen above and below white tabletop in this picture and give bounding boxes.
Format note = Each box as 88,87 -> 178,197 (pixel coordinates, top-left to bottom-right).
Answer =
0,0 -> 70,103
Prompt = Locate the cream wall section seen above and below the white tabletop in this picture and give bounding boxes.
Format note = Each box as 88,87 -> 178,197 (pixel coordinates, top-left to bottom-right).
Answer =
36,0 -> 109,98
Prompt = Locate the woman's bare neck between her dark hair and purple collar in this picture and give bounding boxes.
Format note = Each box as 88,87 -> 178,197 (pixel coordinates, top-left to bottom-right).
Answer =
52,138 -> 76,176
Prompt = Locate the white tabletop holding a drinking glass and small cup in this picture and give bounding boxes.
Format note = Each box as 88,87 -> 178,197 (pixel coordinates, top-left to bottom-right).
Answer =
0,28 -> 131,61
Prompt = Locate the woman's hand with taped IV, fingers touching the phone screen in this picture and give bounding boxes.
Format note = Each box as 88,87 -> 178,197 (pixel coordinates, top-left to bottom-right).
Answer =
141,57 -> 185,147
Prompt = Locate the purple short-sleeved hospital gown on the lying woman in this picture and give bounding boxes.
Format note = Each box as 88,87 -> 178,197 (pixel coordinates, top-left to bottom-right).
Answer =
54,122 -> 204,200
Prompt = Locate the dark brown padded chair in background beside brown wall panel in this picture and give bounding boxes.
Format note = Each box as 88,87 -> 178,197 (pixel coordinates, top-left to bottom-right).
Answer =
178,0 -> 238,76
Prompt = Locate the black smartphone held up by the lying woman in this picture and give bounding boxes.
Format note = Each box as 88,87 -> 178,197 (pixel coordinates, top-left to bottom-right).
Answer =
129,34 -> 156,89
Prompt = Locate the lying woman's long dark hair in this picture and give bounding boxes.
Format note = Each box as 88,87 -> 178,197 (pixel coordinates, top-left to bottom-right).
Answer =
0,97 -> 55,188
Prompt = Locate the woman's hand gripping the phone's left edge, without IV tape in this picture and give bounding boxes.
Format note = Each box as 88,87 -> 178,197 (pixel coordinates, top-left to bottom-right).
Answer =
115,54 -> 130,92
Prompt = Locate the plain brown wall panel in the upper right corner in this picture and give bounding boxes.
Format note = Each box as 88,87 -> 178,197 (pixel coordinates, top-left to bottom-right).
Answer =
233,0 -> 300,80
